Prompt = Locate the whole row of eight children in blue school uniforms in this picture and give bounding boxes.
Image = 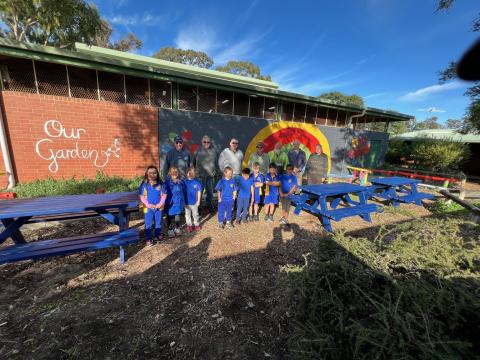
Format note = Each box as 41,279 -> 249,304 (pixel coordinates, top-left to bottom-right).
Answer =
139,163 -> 297,246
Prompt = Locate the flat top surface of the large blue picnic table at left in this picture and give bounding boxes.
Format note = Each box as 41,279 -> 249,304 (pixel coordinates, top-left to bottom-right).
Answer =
0,192 -> 138,219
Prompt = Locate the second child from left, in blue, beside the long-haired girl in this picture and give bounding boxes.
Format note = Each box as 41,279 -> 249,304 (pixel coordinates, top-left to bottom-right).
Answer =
165,166 -> 185,238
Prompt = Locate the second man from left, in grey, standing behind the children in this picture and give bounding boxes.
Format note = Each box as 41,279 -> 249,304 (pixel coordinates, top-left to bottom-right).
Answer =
193,135 -> 217,210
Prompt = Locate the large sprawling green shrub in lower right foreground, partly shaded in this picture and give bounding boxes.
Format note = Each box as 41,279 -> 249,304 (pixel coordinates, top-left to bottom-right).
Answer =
280,218 -> 480,359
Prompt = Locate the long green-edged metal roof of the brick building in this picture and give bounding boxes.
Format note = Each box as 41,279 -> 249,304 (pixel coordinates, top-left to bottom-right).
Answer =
0,39 -> 413,121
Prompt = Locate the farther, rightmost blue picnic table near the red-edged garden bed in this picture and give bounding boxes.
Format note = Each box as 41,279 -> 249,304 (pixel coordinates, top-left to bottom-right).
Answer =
368,176 -> 434,206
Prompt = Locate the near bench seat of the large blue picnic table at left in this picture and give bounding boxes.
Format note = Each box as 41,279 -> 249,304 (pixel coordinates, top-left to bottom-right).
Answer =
0,228 -> 140,264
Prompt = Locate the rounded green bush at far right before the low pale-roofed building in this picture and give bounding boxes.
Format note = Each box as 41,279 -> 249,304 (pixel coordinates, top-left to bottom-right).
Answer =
411,139 -> 470,171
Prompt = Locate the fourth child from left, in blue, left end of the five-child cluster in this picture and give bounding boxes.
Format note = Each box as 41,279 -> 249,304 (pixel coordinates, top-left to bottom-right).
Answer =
215,166 -> 237,229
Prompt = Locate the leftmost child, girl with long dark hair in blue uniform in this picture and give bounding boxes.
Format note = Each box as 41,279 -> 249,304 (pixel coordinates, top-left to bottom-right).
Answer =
138,166 -> 167,246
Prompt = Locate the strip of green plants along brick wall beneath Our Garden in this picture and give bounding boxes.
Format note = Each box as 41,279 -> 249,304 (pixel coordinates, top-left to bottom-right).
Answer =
14,172 -> 142,198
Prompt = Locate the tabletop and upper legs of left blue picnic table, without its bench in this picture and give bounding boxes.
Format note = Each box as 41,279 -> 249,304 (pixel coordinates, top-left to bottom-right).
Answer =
0,192 -> 138,244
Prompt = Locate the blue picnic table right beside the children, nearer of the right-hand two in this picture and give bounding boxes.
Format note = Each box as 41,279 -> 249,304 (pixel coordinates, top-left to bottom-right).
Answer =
292,183 -> 383,232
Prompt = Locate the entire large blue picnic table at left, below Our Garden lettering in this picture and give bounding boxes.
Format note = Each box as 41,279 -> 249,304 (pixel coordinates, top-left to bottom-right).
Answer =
0,192 -> 139,264
